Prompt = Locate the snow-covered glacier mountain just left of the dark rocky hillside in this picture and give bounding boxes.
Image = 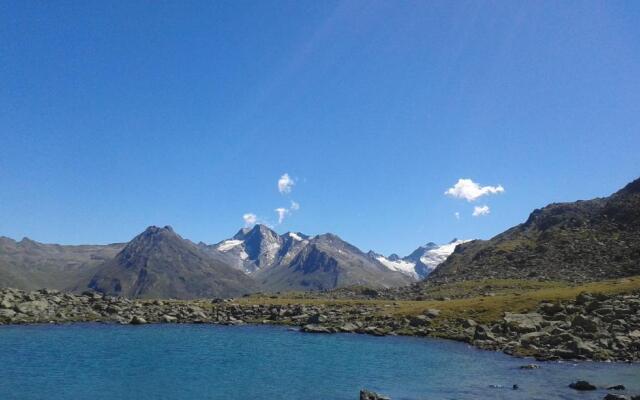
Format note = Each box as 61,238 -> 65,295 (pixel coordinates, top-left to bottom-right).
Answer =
368,239 -> 468,280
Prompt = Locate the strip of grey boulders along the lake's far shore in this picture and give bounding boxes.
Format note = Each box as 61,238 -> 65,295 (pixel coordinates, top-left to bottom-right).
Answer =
0,289 -> 640,362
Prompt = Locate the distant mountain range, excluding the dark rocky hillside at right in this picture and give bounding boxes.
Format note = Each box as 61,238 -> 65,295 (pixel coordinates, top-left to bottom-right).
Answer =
0,224 -> 459,299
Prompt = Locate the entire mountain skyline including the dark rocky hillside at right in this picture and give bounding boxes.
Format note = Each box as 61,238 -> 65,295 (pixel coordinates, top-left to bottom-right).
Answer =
0,179 -> 640,298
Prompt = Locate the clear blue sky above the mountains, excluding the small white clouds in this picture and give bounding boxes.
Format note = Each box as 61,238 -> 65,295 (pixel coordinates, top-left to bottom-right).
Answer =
0,1 -> 640,254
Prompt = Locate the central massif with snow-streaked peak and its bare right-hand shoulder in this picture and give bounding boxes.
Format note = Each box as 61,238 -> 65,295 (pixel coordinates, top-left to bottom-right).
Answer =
207,224 -> 412,291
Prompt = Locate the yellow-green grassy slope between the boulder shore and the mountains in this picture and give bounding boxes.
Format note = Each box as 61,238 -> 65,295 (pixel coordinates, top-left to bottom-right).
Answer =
232,276 -> 640,322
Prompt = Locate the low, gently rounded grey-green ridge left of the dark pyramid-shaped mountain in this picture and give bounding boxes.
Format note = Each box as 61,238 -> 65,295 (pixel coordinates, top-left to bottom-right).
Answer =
0,237 -> 125,290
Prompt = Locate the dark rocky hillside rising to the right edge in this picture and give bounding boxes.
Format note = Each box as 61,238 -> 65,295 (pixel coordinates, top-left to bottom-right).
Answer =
427,179 -> 640,283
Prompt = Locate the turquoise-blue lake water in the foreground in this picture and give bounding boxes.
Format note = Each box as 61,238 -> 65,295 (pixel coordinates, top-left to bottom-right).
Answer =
0,324 -> 640,400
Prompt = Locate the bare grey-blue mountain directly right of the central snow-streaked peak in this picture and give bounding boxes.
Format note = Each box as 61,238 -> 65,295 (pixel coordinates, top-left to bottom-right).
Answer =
256,234 -> 413,291
